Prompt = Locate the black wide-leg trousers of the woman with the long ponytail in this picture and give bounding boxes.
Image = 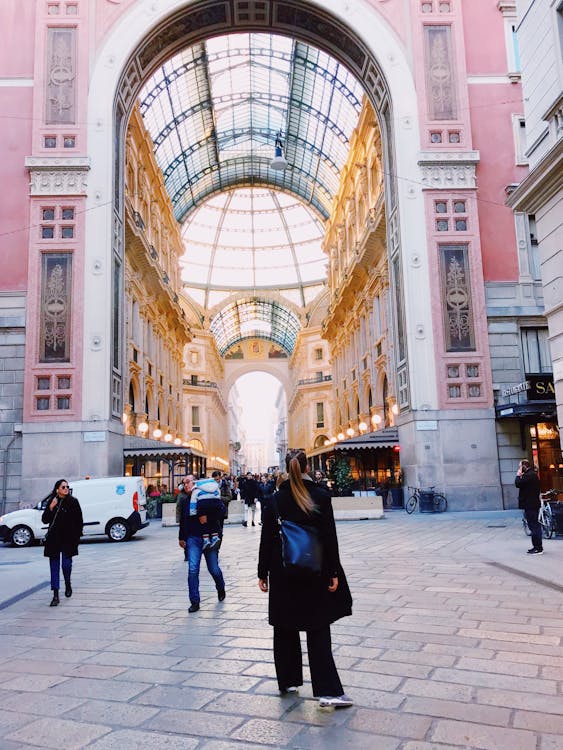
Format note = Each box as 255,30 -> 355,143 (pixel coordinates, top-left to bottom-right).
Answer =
274,625 -> 344,698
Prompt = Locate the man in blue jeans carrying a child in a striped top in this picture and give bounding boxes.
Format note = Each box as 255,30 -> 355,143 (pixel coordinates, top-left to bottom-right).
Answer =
178,476 -> 226,613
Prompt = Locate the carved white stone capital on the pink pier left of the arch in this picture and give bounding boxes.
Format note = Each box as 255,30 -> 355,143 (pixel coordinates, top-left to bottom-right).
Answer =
25,156 -> 90,195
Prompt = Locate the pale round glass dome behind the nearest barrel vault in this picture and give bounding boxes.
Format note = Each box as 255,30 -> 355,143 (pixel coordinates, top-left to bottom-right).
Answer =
182,187 -> 327,308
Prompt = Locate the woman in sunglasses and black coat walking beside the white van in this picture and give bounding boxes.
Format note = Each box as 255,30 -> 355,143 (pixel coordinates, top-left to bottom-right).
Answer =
41,479 -> 83,607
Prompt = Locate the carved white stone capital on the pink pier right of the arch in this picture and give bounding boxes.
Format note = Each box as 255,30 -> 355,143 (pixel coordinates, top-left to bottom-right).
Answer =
418,151 -> 480,190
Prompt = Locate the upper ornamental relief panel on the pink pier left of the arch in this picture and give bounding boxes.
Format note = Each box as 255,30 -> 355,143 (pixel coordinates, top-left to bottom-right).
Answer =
45,28 -> 76,125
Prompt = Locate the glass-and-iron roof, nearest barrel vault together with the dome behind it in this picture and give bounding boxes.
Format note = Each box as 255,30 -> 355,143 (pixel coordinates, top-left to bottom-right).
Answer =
140,33 -> 363,356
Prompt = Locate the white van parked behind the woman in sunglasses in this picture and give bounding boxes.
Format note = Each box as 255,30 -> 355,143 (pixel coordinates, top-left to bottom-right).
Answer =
0,477 -> 149,547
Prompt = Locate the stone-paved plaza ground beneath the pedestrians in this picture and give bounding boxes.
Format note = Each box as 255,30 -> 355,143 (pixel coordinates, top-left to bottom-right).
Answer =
0,512 -> 563,750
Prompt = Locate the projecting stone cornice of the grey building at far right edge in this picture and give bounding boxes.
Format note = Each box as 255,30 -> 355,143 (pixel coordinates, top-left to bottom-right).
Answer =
506,138 -> 563,213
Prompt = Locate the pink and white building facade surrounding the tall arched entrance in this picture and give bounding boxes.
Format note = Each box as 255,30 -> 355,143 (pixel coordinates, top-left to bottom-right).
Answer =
0,0 -> 547,508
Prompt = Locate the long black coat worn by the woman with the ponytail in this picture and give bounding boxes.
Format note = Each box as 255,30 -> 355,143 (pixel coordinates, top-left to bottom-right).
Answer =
258,480 -> 352,630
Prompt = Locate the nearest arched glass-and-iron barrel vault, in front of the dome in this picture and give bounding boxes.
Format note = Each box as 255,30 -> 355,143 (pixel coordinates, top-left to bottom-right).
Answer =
141,34 -> 362,221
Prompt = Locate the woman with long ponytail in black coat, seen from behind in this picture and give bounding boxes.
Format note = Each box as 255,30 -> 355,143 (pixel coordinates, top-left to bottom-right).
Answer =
258,451 -> 352,708
